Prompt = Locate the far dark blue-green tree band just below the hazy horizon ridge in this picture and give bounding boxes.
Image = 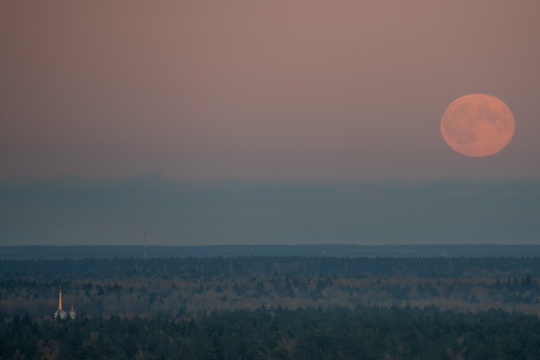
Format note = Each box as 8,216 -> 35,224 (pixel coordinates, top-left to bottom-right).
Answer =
0,256 -> 540,281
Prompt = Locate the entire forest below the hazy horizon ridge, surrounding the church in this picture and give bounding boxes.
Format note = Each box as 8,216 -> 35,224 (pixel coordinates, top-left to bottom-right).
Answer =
0,256 -> 540,359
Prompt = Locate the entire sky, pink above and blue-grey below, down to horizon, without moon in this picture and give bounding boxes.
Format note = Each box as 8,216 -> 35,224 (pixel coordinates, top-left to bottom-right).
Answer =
0,0 -> 540,245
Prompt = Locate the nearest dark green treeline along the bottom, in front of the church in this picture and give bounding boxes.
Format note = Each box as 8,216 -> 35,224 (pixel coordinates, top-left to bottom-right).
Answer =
0,307 -> 540,360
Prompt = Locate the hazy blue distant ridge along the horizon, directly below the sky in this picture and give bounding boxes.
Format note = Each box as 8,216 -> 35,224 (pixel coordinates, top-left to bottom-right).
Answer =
5,244 -> 540,260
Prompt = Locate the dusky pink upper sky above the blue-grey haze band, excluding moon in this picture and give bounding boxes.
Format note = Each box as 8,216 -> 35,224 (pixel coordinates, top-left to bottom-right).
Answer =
0,0 -> 540,180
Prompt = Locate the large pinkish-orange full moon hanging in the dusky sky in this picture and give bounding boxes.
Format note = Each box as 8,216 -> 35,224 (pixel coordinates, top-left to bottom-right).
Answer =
441,94 -> 515,157
